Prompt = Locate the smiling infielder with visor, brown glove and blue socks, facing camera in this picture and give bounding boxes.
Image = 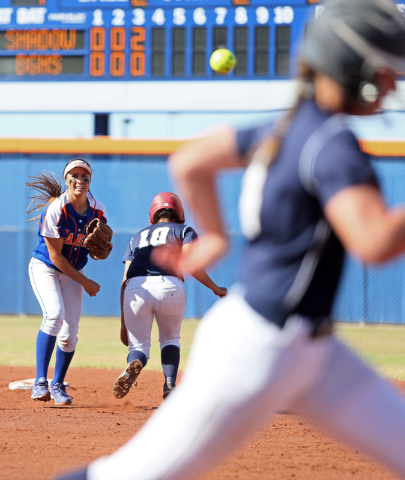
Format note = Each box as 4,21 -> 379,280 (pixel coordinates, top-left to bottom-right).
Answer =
27,159 -> 107,405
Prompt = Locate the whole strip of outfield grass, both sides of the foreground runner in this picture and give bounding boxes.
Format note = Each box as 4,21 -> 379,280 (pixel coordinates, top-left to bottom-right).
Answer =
0,316 -> 405,380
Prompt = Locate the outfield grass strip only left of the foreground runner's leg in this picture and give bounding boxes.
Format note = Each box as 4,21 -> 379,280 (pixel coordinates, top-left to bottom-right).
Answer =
0,316 -> 198,370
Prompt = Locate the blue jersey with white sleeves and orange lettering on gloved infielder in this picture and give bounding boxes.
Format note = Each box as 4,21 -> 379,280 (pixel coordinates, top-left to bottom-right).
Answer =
32,191 -> 107,270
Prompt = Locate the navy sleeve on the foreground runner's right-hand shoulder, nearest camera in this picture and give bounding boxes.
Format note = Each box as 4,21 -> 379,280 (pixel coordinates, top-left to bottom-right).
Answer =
313,130 -> 379,207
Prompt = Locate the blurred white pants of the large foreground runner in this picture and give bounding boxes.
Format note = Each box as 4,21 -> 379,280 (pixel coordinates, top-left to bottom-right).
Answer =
87,294 -> 405,480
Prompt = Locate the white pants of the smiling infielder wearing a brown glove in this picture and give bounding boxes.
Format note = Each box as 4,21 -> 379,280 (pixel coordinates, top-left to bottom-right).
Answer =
28,258 -> 83,352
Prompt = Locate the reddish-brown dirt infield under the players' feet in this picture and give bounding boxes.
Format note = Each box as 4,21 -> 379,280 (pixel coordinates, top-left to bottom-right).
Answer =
0,367 -> 405,480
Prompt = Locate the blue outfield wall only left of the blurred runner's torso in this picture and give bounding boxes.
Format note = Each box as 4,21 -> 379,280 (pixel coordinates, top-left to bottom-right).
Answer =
0,154 -> 245,318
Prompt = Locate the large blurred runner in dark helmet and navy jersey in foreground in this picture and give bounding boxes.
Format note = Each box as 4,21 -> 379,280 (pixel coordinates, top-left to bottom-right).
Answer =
53,0 -> 405,480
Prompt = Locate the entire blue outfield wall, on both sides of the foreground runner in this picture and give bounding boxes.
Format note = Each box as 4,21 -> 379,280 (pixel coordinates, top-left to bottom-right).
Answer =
0,154 -> 405,324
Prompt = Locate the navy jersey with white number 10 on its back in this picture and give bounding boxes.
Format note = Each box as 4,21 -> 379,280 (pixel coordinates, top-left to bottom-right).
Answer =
123,222 -> 198,280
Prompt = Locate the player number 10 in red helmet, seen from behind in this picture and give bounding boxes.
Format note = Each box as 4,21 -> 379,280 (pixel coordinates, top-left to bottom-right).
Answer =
113,192 -> 227,398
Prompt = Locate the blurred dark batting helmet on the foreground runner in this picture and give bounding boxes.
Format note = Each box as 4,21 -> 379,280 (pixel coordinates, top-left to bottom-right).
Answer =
302,0 -> 405,97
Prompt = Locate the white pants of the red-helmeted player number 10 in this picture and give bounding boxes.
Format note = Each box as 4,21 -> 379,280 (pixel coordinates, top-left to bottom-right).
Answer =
124,275 -> 186,358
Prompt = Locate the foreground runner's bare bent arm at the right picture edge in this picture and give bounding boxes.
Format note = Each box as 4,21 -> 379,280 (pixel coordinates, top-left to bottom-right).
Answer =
325,185 -> 405,263
